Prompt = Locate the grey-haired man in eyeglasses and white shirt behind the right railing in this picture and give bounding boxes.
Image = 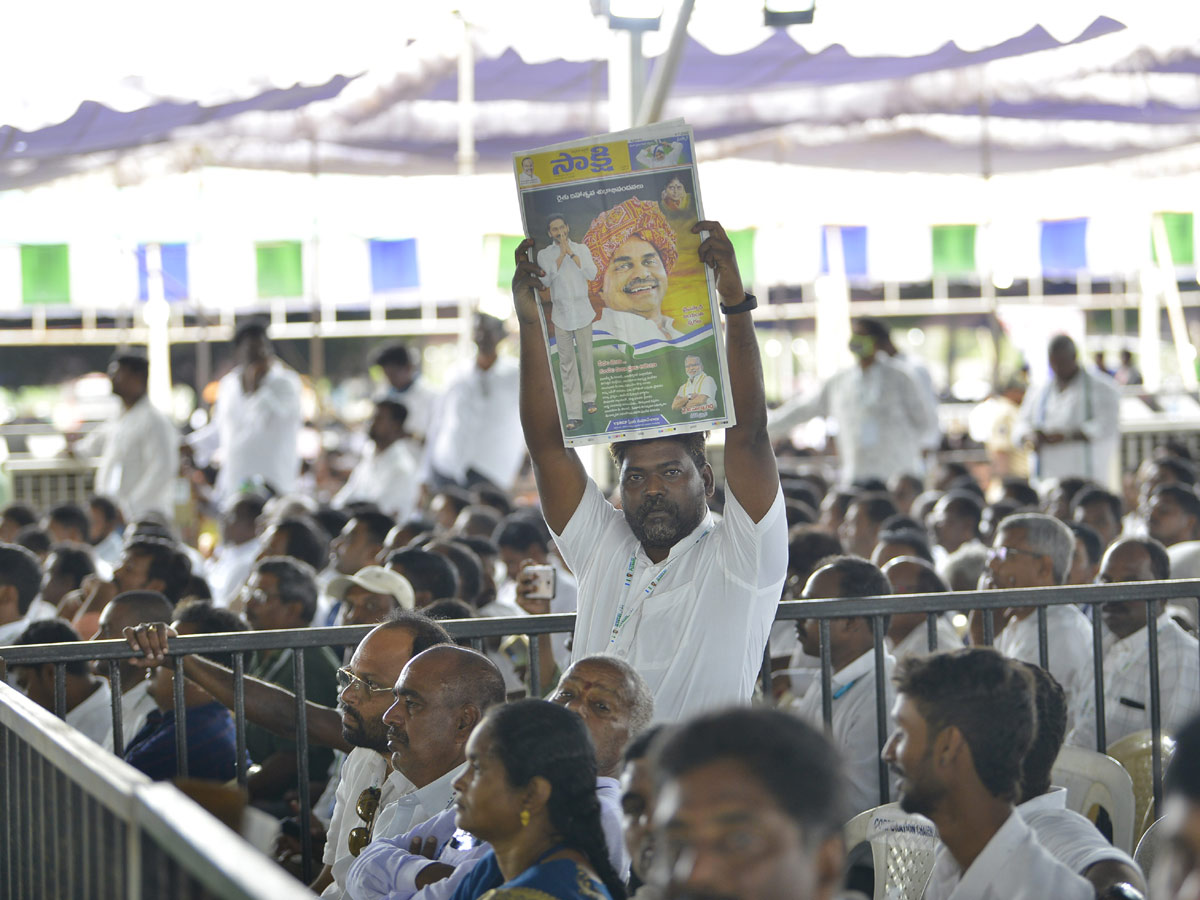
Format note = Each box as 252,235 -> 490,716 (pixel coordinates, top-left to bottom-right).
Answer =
979,512 -> 1093,731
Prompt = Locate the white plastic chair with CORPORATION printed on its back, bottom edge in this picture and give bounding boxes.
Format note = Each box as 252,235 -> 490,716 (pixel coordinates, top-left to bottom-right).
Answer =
844,803 -> 938,900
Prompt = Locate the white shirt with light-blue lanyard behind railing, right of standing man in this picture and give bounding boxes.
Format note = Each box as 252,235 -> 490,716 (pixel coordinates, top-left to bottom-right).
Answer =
791,648 -> 895,815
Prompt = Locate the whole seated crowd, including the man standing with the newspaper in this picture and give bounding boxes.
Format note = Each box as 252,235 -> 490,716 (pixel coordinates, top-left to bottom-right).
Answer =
0,248 -> 1200,900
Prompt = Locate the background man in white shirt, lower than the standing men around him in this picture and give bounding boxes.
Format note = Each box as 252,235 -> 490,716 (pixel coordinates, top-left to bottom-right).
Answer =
334,395 -> 421,520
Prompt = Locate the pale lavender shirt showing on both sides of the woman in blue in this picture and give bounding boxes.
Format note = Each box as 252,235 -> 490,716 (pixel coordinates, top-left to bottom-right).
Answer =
346,776 -> 629,900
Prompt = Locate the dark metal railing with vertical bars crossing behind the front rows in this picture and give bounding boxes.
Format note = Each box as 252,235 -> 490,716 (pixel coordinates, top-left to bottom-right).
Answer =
0,580 -> 1200,880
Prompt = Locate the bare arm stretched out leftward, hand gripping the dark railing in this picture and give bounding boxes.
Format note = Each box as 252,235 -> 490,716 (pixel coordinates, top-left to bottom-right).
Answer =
125,622 -> 354,752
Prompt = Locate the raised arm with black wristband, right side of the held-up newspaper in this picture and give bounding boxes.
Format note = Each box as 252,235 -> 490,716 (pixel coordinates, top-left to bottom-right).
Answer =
691,222 -> 779,522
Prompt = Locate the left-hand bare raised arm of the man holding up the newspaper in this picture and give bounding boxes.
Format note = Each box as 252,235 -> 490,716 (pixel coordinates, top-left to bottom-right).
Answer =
512,238 -> 588,534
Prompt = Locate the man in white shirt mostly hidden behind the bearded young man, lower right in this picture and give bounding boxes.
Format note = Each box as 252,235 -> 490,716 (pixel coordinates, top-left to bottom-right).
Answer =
1016,662 -> 1146,898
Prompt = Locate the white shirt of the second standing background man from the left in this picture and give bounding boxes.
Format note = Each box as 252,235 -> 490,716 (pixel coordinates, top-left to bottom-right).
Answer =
191,360 -> 304,498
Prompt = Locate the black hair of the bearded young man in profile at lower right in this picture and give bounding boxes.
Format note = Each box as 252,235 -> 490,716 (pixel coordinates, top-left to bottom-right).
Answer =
893,647 -> 1037,800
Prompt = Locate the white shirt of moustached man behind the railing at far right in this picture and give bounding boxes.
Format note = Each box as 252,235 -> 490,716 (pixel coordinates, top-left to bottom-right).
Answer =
1067,614 -> 1200,750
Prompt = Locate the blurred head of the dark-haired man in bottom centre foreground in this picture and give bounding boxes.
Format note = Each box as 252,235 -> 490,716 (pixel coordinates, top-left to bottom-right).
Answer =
653,708 -> 845,900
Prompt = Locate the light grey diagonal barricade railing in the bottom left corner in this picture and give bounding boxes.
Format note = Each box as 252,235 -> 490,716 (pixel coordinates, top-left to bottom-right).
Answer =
0,683 -> 312,900
